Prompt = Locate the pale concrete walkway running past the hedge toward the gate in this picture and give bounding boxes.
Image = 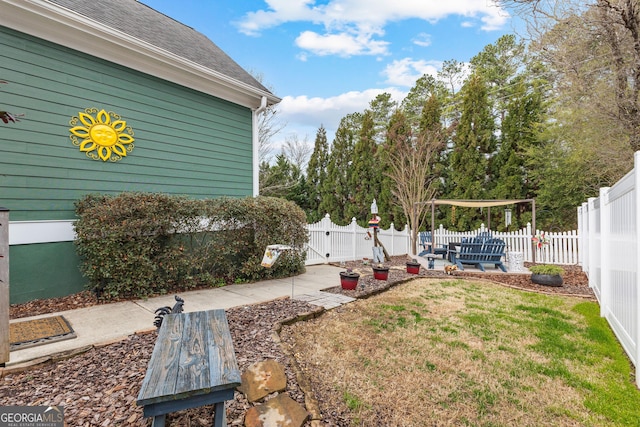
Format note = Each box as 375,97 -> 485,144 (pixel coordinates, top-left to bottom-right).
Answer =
6,265 -> 353,370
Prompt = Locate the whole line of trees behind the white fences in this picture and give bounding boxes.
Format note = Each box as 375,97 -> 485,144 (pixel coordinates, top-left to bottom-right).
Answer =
260,0 -> 640,237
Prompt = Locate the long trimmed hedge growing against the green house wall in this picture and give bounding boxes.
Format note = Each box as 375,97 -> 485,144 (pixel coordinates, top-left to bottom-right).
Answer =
75,193 -> 308,299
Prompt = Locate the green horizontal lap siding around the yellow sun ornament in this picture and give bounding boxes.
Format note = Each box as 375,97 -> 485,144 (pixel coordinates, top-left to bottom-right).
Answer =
0,28 -> 253,224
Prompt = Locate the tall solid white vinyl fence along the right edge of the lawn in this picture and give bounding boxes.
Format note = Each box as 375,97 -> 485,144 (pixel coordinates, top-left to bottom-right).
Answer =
578,152 -> 640,386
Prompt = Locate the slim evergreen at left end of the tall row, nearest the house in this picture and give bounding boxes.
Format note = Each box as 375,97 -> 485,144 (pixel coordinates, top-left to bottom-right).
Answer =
307,125 -> 329,223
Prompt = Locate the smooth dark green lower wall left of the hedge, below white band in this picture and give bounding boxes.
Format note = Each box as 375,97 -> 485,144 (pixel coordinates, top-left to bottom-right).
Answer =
9,242 -> 87,304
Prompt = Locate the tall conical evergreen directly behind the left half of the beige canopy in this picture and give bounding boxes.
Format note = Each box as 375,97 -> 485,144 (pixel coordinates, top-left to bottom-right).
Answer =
449,74 -> 496,230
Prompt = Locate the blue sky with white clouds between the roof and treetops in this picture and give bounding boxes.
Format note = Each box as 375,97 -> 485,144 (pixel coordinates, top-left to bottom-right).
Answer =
140,0 -> 515,156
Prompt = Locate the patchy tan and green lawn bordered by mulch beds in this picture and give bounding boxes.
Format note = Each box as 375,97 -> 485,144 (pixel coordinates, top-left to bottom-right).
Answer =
283,279 -> 640,426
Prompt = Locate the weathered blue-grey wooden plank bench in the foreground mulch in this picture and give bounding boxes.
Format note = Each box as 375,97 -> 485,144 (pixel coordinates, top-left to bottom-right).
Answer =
136,310 -> 240,427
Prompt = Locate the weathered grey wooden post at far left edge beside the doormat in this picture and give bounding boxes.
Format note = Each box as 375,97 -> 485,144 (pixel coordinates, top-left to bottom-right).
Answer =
0,208 -> 10,366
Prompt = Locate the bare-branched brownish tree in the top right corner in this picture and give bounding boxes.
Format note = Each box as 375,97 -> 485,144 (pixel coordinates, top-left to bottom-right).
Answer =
498,0 -> 640,151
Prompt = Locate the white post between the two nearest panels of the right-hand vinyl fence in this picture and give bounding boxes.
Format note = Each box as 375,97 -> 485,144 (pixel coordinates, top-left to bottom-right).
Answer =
600,187 -> 611,318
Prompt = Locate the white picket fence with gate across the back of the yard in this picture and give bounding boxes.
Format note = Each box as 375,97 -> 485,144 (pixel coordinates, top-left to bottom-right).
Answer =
306,214 -> 579,265
